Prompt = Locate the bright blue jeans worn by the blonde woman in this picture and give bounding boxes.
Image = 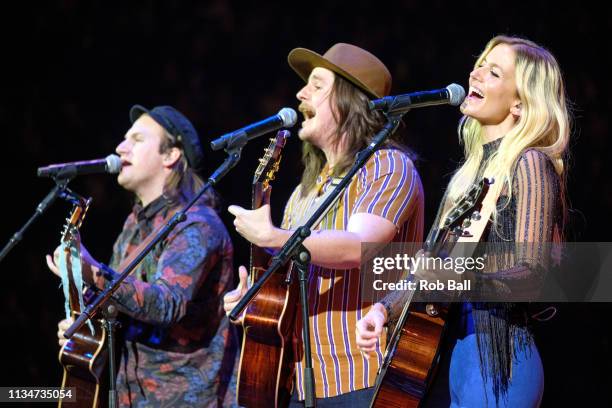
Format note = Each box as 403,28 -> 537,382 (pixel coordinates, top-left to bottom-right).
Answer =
449,334 -> 544,408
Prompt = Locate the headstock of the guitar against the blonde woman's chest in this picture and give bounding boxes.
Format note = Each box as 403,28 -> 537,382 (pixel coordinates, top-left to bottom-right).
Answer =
442,178 -> 494,236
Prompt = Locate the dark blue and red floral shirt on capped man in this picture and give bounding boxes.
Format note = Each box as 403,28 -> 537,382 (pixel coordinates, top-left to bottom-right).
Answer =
104,196 -> 237,407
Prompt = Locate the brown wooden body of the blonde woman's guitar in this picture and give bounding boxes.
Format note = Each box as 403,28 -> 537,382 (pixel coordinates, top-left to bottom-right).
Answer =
371,304 -> 449,408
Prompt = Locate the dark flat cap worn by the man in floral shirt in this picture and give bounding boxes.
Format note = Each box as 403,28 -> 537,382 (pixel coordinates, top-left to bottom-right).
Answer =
130,105 -> 204,169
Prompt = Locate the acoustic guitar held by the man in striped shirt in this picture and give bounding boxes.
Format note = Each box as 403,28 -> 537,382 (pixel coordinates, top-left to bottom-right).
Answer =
237,130 -> 299,408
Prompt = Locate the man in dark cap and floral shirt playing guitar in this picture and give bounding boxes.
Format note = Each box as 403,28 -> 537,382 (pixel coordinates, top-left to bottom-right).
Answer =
47,105 -> 236,407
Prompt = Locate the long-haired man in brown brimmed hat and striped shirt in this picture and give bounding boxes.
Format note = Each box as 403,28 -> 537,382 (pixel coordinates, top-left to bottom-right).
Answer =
224,43 -> 423,407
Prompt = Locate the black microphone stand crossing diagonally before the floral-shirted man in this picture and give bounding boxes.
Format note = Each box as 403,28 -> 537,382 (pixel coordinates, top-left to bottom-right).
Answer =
64,142 -> 248,408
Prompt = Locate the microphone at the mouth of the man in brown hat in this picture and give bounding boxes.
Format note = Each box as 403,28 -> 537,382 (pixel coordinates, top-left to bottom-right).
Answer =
210,108 -> 297,150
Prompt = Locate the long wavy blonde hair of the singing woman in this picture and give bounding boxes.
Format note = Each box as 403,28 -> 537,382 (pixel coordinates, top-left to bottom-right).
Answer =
445,36 -> 571,230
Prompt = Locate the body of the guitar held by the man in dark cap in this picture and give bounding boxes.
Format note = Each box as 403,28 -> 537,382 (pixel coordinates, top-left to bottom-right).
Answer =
59,314 -> 108,408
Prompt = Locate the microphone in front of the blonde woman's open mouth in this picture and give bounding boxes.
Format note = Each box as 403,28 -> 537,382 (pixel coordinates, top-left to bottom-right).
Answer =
369,84 -> 465,113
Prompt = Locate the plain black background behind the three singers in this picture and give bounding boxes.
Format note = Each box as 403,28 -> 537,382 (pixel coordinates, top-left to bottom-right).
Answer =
0,0 -> 612,406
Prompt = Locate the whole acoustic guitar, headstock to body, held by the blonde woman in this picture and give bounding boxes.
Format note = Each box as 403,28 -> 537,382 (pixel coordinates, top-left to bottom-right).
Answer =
370,179 -> 492,408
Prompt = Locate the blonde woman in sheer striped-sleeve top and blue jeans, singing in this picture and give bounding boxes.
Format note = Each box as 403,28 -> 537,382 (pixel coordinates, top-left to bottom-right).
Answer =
356,36 -> 570,407
